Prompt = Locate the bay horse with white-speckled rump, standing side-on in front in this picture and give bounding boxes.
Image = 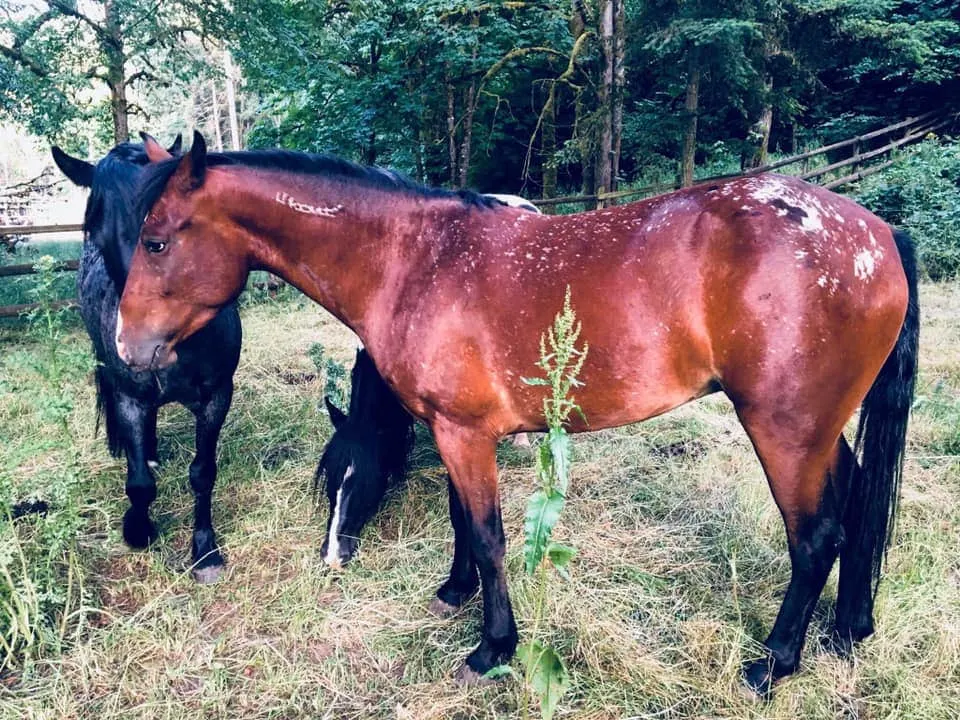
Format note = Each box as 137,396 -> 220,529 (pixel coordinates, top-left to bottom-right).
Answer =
116,134 -> 919,694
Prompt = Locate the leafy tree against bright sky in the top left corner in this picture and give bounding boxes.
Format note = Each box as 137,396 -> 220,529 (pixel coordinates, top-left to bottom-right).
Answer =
0,0 -> 216,149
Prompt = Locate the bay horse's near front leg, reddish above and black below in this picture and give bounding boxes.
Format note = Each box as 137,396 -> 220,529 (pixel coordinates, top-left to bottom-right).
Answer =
433,420 -> 517,683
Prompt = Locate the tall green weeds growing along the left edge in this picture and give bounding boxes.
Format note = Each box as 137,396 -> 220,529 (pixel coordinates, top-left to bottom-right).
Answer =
0,255 -> 93,672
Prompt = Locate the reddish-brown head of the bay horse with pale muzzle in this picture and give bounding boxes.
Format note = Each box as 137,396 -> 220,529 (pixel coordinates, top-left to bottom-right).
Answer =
117,133 -> 249,369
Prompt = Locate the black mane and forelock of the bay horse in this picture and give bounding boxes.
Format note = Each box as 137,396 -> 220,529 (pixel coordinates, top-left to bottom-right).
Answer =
138,144 -> 503,217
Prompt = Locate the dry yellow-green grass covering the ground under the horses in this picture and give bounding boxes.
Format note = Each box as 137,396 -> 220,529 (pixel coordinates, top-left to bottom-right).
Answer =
0,284 -> 960,720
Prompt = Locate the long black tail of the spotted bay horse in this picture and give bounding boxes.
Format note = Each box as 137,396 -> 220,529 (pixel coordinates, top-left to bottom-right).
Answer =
848,230 -> 920,596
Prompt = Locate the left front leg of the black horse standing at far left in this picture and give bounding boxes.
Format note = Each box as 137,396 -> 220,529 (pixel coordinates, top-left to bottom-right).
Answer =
114,391 -> 157,548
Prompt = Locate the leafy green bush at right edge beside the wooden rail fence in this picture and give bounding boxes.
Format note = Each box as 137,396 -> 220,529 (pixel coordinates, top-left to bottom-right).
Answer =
855,137 -> 960,280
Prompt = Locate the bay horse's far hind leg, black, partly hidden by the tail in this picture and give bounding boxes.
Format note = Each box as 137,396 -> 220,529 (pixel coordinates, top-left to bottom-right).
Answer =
833,437 -> 873,655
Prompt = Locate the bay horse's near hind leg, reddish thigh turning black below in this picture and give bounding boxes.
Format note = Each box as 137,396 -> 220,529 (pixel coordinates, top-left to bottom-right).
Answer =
737,407 -> 849,695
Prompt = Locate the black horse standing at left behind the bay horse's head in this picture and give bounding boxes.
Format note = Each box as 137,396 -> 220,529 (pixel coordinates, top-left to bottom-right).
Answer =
52,137 -> 241,582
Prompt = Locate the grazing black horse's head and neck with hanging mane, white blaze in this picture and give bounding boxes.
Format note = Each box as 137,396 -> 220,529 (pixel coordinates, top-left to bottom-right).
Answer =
314,350 -> 413,567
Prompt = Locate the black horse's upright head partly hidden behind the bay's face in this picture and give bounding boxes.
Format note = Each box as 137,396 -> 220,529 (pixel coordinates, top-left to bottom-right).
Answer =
51,135 -> 181,293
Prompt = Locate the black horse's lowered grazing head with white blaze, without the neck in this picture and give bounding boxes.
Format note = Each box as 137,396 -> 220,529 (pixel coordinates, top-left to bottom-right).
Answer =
314,398 -> 388,567
